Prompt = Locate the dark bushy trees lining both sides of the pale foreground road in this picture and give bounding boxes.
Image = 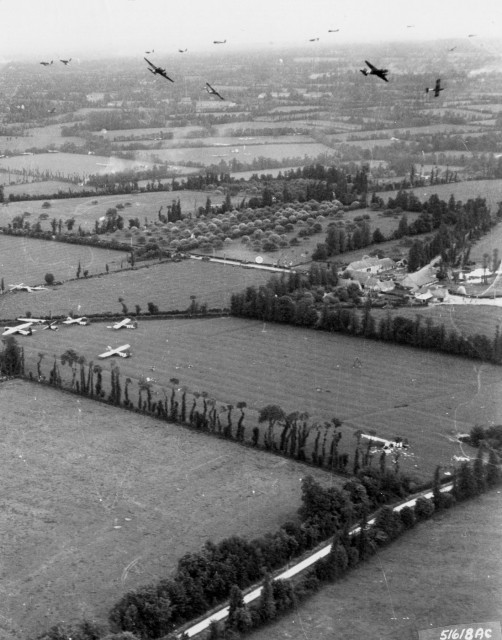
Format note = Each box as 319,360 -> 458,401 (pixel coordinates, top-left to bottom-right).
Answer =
37,450 -> 500,640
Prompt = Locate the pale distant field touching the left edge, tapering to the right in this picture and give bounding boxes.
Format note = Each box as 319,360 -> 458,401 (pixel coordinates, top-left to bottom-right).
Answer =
0,153 -> 154,178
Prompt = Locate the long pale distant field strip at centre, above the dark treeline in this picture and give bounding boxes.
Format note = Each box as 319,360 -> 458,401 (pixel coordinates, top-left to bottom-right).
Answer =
135,142 -> 331,166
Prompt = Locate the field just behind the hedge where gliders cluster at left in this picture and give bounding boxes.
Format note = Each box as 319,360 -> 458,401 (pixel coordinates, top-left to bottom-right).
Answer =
0,260 -> 270,318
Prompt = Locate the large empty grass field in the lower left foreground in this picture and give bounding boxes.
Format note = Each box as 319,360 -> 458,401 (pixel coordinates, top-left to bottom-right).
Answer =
0,380 -> 341,640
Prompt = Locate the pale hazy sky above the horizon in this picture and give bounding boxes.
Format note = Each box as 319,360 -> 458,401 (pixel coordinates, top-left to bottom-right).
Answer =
0,0 -> 502,60
